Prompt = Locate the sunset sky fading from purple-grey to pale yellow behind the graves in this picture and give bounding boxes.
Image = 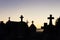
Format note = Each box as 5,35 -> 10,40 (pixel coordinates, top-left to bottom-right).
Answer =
0,0 -> 60,28
